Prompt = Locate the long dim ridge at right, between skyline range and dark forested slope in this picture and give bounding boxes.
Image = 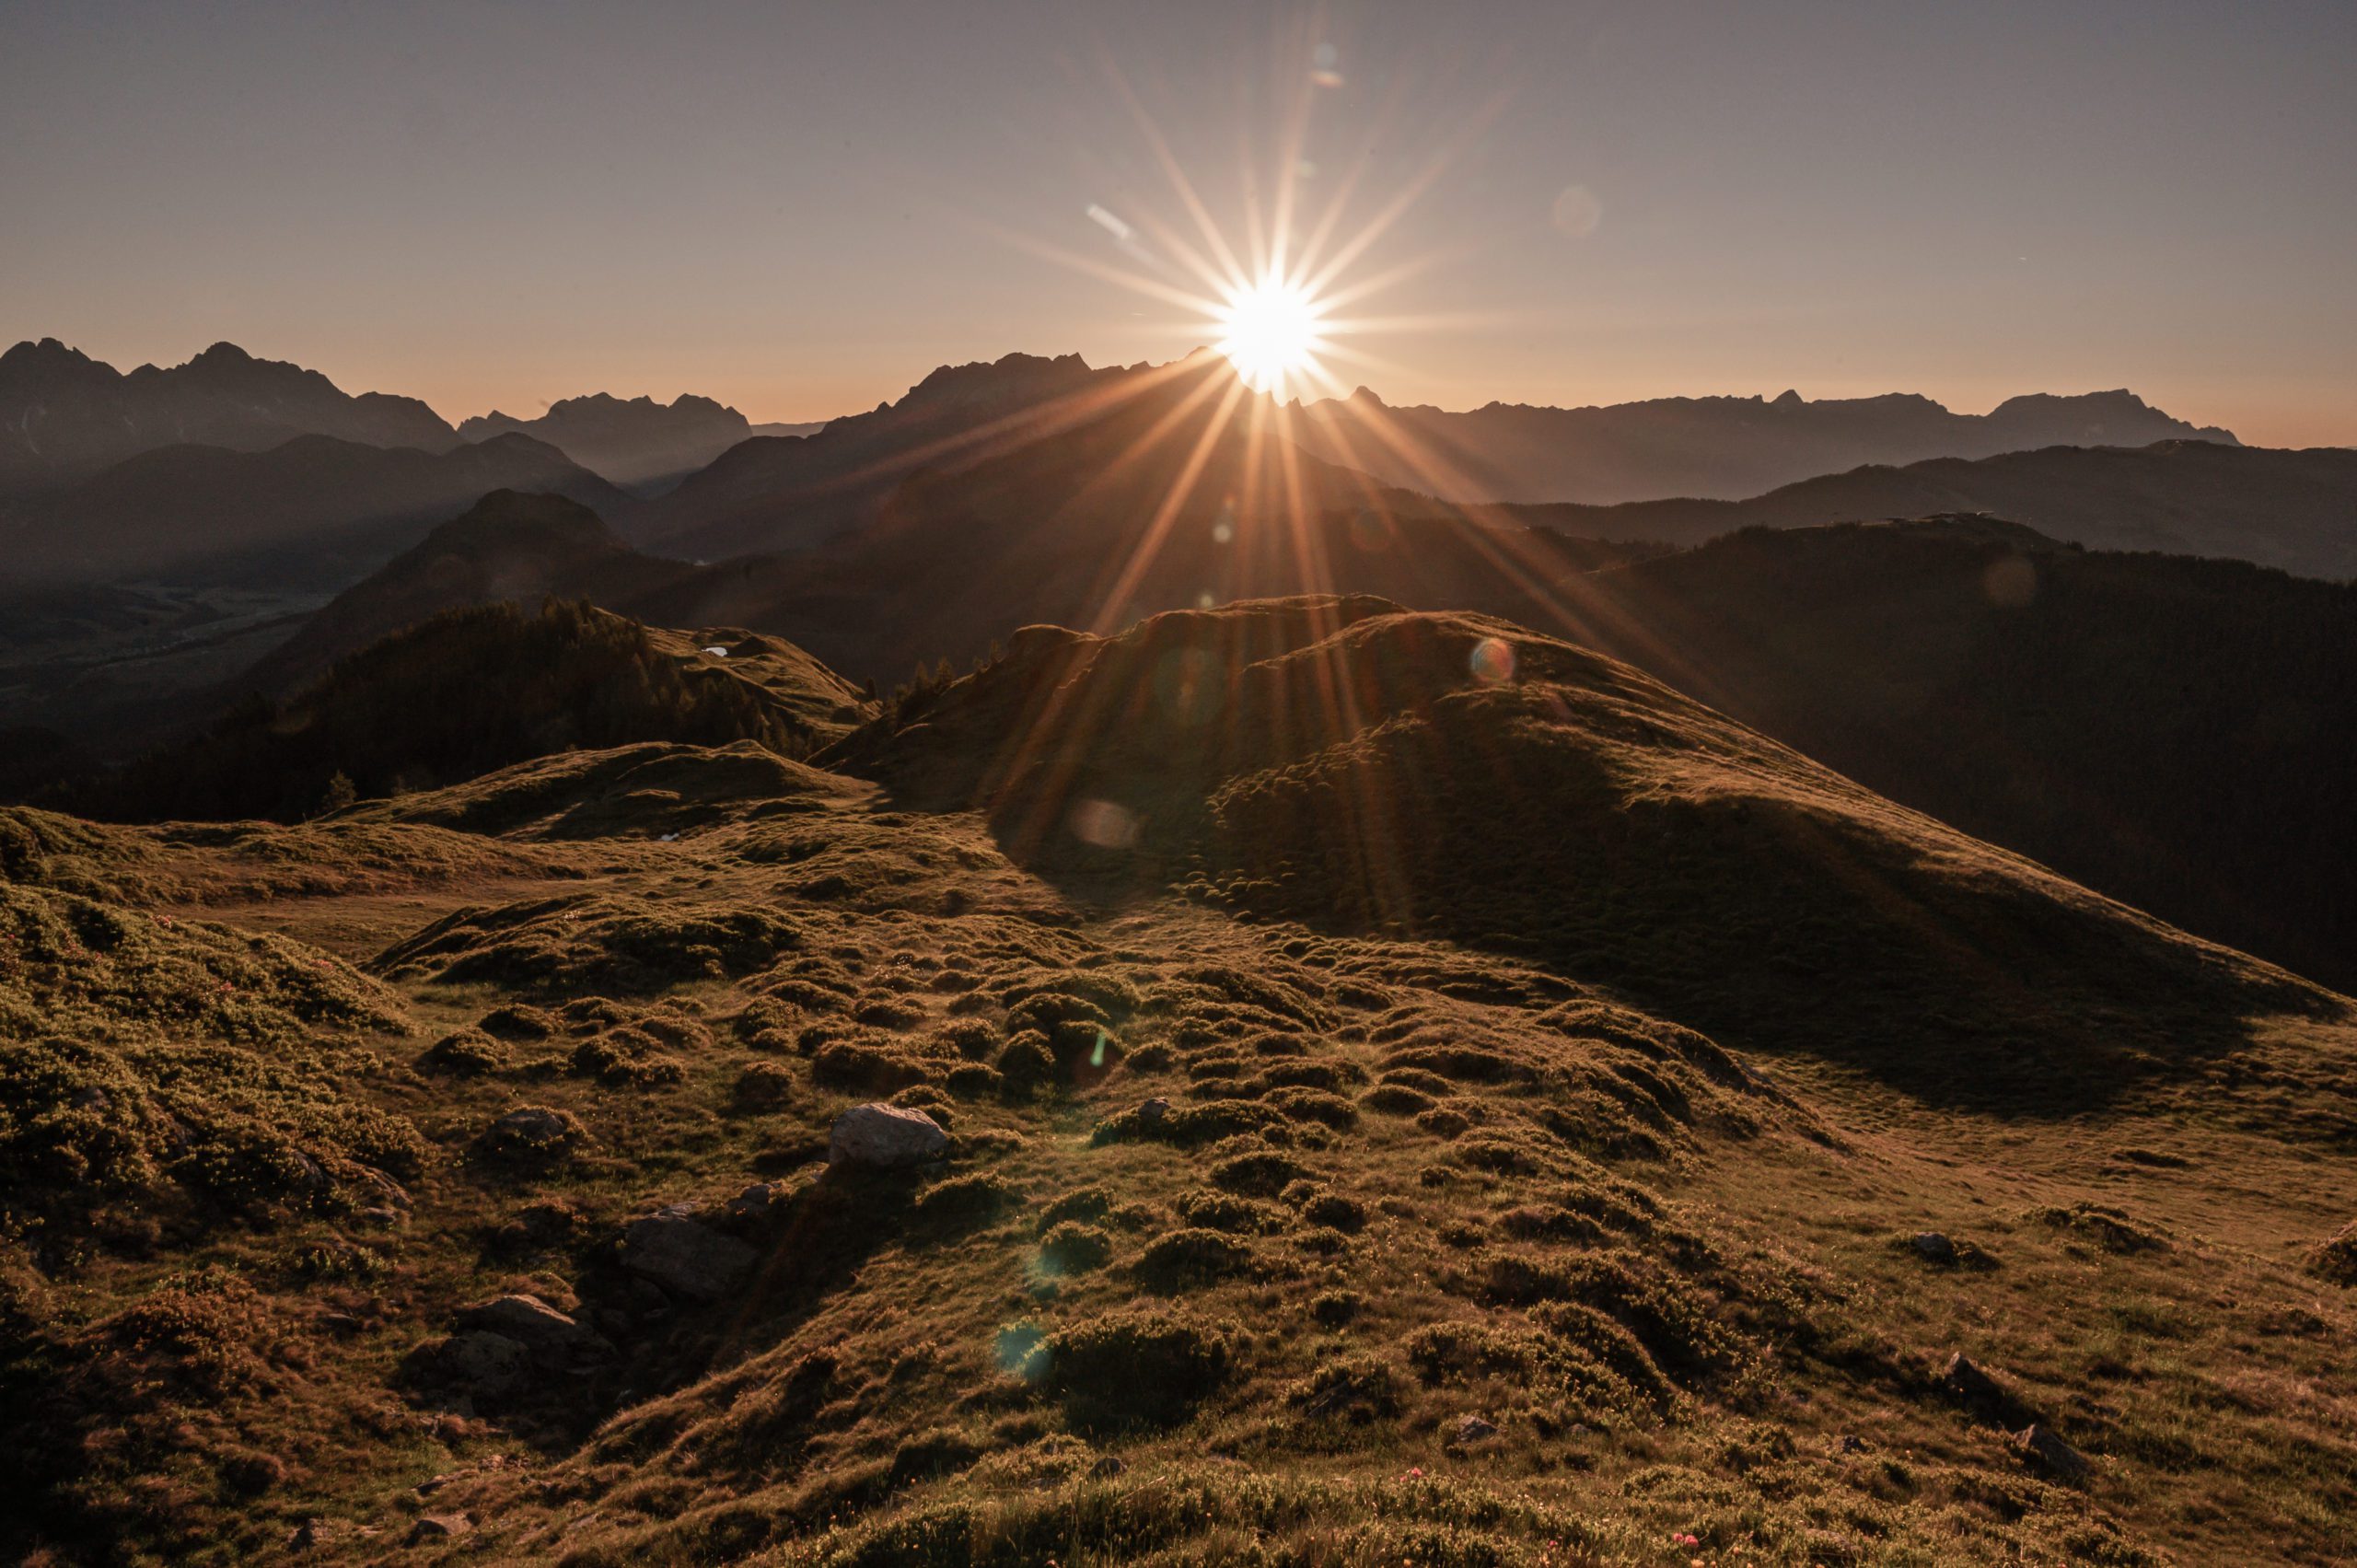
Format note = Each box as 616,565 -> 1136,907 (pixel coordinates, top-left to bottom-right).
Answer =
1506,441 -> 2357,580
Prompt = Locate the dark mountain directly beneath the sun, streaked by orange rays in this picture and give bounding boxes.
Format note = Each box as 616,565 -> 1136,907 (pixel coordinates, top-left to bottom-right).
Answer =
618,356 -> 1659,681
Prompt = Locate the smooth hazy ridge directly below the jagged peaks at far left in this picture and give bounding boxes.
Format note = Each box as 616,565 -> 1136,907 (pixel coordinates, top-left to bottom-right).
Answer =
0,436 -> 632,587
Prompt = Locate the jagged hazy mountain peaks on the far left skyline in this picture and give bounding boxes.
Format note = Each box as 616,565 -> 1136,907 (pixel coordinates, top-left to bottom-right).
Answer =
0,337 -> 458,491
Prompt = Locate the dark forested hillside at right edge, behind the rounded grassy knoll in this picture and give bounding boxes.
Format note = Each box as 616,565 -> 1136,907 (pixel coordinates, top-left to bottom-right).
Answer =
1561,518 -> 2357,988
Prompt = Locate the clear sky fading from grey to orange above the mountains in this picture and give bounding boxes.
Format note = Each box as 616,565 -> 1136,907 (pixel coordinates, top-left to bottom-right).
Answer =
0,0 -> 2357,446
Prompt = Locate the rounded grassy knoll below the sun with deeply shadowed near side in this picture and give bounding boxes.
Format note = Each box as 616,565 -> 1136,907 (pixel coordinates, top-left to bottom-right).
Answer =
837,598 -> 2336,1113
